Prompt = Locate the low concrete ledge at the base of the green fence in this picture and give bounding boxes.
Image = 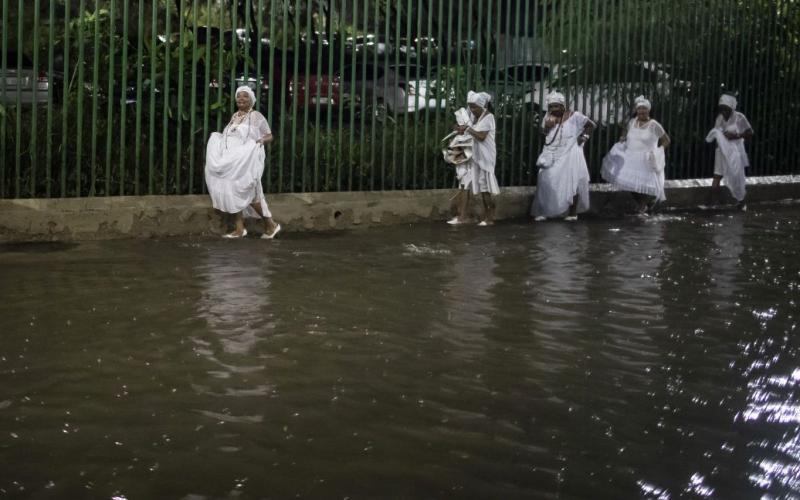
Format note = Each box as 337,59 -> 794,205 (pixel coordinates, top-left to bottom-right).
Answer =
0,176 -> 800,241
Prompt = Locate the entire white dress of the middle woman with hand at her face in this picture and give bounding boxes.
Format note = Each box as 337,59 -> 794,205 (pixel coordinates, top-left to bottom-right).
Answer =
531,111 -> 589,217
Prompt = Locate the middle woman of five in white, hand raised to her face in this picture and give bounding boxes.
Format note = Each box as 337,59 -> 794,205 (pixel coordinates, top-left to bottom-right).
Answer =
531,92 -> 596,221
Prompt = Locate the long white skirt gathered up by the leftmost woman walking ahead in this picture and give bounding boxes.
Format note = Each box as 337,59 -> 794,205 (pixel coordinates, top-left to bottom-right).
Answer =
206,132 -> 272,218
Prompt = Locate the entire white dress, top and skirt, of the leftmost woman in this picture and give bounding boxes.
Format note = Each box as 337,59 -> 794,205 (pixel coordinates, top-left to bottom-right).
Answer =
205,111 -> 272,218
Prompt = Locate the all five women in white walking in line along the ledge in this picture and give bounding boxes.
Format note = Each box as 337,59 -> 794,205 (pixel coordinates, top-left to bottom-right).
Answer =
205,86 -> 753,239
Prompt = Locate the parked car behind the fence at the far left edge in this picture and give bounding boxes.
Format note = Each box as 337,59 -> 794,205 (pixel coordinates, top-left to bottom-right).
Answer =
0,51 -> 64,106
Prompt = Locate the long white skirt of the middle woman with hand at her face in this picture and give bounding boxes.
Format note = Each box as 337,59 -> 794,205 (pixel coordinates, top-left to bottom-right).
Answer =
531,144 -> 589,217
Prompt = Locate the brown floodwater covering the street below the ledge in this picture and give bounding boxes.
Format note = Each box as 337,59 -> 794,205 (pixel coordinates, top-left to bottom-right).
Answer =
0,204 -> 800,500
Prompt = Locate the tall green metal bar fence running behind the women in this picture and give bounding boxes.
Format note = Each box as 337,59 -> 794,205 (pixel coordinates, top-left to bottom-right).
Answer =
0,0 -> 800,198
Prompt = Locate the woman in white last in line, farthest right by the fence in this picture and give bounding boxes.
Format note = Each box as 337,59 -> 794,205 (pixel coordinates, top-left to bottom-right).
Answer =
700,94 -> 753,210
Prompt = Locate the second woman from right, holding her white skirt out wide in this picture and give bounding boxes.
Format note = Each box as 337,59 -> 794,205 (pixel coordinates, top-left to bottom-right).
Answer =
600,97 -> 670,215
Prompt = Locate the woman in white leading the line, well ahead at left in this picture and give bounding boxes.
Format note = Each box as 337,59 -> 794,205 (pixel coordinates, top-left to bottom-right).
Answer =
206,87 -> 281,239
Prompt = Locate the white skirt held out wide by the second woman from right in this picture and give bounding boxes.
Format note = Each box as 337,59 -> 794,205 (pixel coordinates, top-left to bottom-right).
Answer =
600,143 -> 667,201
